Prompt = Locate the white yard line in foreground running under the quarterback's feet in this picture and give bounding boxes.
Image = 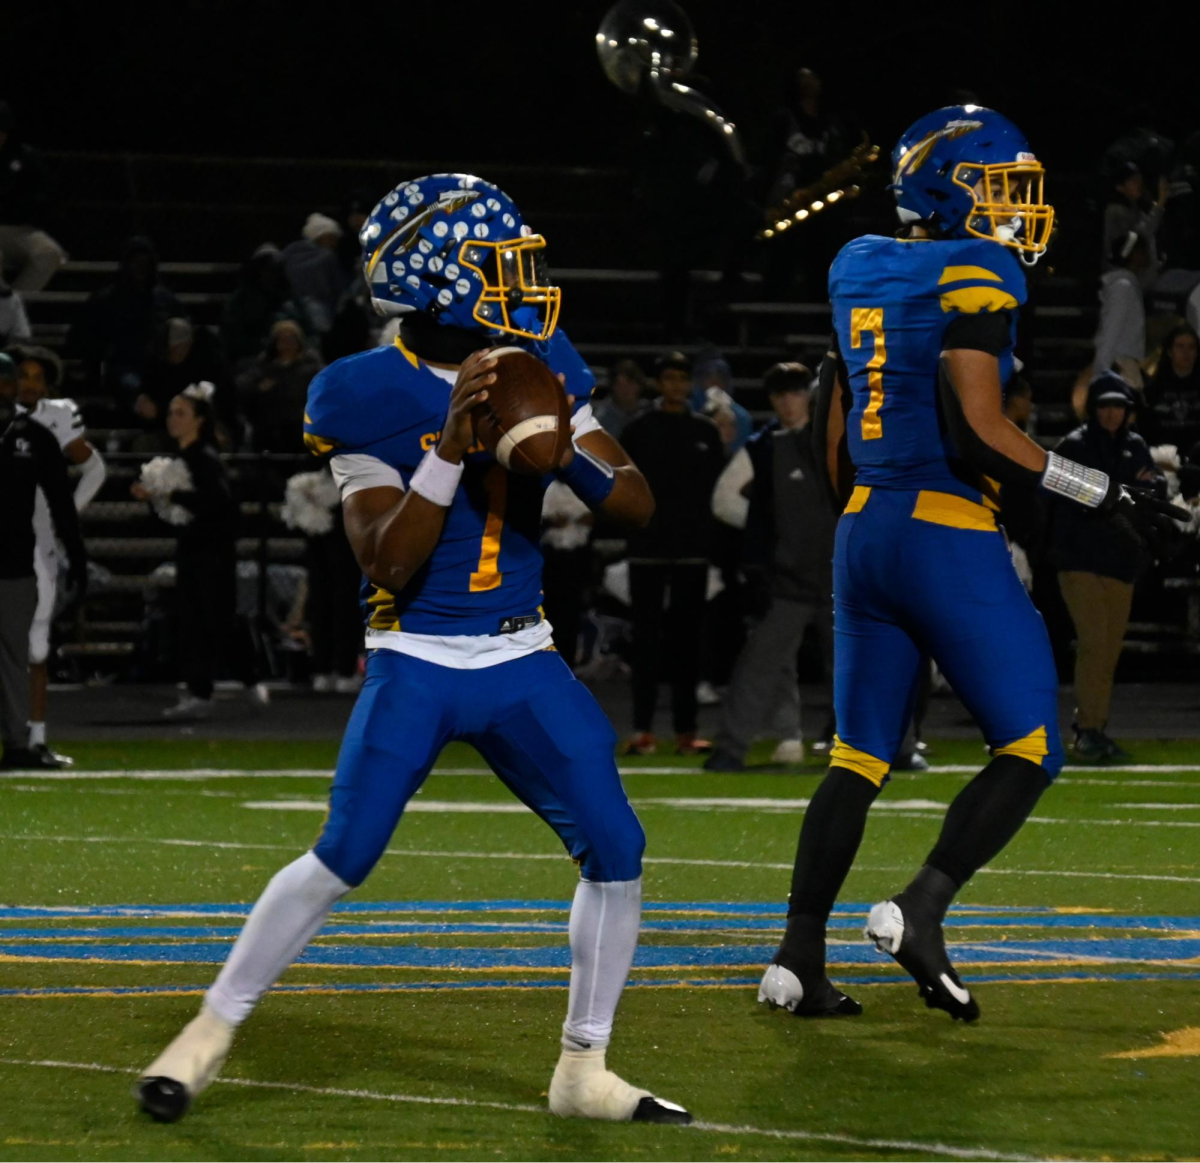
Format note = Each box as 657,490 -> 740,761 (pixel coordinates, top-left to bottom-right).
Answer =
0,1057 -> 1099,1163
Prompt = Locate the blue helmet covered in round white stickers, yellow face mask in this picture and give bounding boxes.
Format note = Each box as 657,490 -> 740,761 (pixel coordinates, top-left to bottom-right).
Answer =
359,174 -> 562,340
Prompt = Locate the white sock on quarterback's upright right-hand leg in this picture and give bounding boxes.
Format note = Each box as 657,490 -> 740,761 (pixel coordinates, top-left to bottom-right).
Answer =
563,877 -> 642,1050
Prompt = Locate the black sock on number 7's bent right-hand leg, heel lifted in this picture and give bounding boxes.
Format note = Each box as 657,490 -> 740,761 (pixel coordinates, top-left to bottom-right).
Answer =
913,755 -> 1049,888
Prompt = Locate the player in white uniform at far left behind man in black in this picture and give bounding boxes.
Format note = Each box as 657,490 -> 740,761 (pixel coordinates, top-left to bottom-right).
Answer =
12,347 -> 106,768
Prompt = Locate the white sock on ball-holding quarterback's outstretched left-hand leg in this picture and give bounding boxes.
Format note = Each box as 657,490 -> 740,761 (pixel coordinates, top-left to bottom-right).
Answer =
205,852 -> 350,1026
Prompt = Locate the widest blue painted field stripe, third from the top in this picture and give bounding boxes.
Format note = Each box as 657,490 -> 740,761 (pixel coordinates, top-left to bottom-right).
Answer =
0,937 -> 1200,970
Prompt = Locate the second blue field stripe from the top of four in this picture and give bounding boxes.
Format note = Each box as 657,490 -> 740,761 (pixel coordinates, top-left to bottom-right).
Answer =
0,913 -> 1200,941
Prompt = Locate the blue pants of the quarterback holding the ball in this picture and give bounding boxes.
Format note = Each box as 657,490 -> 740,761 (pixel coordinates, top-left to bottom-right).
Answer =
313,651 -> 646,885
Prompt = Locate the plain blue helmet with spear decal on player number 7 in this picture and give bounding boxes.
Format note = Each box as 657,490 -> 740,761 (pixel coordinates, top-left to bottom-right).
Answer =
889,104 -> 1054,265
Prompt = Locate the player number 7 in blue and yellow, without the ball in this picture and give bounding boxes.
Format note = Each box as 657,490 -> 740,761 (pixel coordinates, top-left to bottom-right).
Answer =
758,106 -> 1166,1021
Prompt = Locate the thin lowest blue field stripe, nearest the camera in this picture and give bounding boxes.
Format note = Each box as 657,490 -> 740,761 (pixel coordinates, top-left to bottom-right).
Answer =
0,971 -> 1200,999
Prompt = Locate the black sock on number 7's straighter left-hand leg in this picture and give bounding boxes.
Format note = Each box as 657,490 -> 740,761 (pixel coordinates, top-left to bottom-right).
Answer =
775,767 -> 880,981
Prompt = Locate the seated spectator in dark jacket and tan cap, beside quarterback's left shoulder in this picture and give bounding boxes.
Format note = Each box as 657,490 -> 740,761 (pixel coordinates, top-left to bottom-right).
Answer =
238,319 -> 322,452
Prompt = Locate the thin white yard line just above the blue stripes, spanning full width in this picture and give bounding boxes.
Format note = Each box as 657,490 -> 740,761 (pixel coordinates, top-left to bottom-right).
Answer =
0,833 -> 1200,885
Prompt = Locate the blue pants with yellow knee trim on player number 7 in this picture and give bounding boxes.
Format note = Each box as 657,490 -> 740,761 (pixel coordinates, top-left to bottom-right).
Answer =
833,488 -> 1063,783
